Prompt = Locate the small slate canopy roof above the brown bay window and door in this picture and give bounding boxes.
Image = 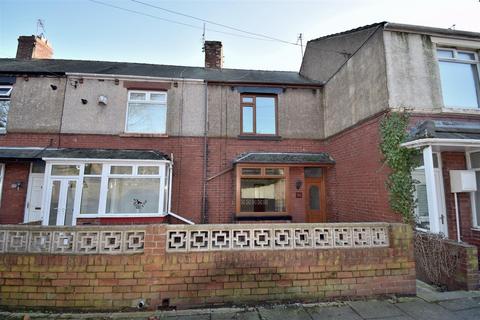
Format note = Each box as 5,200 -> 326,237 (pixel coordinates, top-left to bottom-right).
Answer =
233,152 -> 335,164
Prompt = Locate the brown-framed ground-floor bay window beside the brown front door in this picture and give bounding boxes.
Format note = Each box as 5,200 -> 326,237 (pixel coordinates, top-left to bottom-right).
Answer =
237,166 -> 288,216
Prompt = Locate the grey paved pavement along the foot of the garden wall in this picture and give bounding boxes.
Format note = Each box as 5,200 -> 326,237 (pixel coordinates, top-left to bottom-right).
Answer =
0,282 -> 480,320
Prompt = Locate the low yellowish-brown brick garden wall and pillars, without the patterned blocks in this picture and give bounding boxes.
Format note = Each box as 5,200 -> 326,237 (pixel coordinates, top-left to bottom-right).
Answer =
0,224 -> 415,310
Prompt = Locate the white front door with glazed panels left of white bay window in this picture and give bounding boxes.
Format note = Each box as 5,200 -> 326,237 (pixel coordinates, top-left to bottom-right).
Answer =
47,178 -> 77,226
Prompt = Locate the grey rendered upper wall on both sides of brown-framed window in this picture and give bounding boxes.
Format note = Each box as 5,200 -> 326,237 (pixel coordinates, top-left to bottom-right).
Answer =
208,85 -> 323,139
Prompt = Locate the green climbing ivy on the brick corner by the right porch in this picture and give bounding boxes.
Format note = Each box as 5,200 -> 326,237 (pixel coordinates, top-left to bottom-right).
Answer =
380,112 -> 420,224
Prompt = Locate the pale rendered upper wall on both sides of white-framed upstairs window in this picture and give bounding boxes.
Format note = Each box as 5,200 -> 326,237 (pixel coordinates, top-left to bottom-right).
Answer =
62,79 -> 205,136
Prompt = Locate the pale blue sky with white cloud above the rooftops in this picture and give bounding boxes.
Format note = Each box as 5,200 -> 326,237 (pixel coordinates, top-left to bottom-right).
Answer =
0,0 -> 480,71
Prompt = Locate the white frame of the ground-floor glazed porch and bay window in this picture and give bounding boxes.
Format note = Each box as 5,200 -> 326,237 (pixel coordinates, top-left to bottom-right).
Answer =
42,158 -> 172,225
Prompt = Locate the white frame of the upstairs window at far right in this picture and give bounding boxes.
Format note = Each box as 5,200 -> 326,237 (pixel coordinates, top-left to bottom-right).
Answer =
435,44 -> 480,109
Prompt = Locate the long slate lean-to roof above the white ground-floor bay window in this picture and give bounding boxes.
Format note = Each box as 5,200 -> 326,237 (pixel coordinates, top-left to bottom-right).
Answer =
0,147 -> 169,160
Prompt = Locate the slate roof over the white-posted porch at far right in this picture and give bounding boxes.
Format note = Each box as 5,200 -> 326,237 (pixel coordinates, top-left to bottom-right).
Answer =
407,120 -> 480,141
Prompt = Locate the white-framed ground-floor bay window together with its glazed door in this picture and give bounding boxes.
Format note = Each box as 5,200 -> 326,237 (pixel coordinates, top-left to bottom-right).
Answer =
44,159 -> 171,224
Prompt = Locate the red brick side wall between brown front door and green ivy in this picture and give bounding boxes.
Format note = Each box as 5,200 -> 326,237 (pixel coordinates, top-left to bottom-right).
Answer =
326,114 -> 402,222
